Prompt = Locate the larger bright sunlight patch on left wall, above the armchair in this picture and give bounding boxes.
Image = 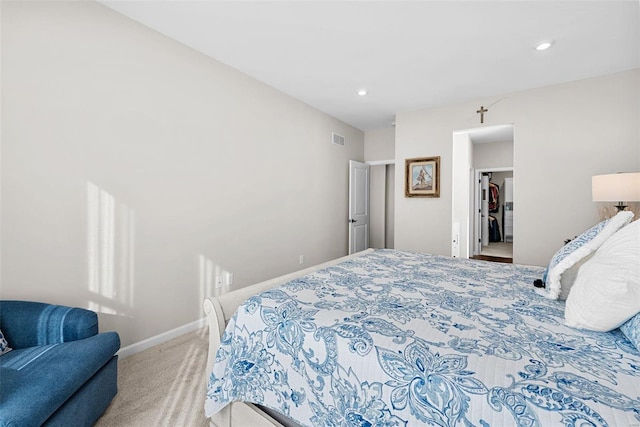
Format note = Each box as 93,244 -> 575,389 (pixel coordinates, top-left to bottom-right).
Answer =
87,182 -> 135,315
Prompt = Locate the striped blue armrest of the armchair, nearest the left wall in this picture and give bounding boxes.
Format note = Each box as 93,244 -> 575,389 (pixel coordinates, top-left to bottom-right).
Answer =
0,301 -> 98,348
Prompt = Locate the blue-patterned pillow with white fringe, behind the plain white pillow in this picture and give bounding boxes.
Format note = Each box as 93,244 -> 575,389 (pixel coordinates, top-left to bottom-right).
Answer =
543,211 -> 633,300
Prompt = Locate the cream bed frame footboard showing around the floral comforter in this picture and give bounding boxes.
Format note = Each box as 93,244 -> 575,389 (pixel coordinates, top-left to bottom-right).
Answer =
204,249 -> 373,427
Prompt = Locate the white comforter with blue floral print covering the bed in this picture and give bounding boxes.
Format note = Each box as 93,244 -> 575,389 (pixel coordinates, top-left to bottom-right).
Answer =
205,250 -> 640,427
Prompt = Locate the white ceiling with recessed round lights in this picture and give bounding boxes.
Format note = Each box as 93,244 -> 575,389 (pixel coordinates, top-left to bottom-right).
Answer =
98,0 -> 640,131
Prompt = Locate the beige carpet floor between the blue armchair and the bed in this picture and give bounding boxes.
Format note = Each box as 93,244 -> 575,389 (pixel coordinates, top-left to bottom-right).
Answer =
96,327 -> 209,427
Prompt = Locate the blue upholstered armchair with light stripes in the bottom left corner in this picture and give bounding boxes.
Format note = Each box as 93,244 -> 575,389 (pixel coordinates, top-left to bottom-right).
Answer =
0,301 -> 120,427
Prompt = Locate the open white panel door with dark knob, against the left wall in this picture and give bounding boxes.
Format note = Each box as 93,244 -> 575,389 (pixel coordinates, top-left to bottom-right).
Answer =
349,160 -> 369,254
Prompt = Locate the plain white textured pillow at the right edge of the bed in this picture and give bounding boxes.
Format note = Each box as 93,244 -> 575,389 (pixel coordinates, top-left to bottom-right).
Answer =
564,221 -> 640,332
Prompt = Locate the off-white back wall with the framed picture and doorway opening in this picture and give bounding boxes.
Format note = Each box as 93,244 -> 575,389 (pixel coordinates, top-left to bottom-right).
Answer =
395,69 -> 640,265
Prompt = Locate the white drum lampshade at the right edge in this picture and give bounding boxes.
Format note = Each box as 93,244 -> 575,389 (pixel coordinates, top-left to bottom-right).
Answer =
591,172 -> 640,202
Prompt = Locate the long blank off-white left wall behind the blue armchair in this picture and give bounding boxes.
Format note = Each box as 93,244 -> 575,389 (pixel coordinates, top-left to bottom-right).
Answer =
1,2 -> 364,345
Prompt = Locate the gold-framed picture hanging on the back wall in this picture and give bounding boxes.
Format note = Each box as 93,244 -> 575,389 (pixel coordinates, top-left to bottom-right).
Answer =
404,156 -> 440,197
